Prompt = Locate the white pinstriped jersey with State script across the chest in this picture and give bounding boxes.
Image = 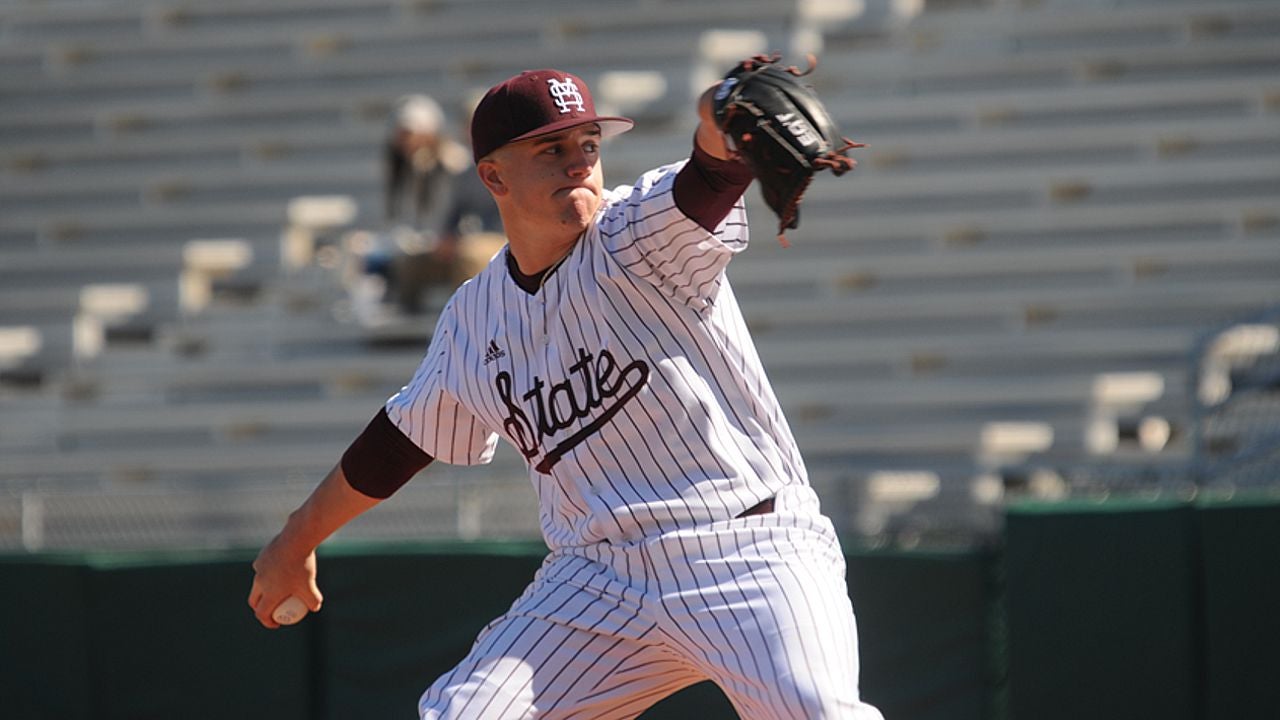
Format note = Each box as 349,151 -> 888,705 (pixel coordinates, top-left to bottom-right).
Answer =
387,163 -> 808,550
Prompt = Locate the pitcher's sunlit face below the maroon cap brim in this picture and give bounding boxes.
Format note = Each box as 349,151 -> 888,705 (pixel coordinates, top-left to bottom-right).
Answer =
488,123 -> 604,236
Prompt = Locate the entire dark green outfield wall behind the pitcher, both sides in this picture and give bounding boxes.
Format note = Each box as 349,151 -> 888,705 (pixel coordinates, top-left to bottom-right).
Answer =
0,500 -> 1280,720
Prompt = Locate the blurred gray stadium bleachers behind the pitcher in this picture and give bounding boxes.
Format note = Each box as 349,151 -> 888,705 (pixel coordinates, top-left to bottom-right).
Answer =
0,0 -> 1280,548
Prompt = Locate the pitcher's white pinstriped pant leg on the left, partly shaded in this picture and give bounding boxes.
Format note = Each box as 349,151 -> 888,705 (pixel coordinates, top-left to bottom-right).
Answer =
419,545 -> 704,720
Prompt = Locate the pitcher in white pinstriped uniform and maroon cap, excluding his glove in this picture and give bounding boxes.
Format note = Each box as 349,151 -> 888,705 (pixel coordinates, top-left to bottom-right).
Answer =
248,69 -> 882,720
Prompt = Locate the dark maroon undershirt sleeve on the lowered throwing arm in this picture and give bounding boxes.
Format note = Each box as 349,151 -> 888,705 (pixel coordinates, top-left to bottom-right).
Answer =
342,407 -> 431,500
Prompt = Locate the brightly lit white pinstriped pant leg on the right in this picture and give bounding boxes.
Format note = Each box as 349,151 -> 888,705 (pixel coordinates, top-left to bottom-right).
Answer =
653,486 -> 883,720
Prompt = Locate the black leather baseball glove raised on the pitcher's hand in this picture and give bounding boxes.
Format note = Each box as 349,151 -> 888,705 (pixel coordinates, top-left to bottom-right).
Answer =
712,55 -> 863,246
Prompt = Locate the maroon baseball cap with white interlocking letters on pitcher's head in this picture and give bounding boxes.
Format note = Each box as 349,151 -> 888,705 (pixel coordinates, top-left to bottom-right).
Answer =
471,69 -> 635,163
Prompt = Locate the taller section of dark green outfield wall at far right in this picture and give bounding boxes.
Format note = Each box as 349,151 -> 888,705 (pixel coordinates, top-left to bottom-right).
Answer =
1002,497 -> 1280,720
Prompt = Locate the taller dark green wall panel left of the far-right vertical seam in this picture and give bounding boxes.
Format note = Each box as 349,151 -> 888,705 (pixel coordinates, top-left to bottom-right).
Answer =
1005,502 -> 1199,720
